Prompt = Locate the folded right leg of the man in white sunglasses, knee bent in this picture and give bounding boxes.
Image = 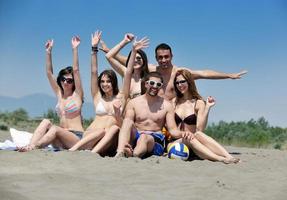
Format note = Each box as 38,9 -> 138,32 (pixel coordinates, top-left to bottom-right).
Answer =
133,134 -> 154,158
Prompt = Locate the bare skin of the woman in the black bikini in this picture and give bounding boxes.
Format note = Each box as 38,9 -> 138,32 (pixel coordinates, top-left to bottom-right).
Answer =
174,75 -> 242,164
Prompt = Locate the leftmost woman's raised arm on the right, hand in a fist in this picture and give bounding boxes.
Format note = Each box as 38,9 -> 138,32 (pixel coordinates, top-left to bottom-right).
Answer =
71,36 -> 84,100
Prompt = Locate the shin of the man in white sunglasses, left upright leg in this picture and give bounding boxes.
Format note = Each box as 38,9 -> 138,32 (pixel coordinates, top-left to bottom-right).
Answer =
116,119 -> 135,157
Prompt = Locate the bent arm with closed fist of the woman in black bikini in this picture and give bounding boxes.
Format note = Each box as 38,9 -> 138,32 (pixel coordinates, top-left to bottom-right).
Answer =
195,96 -> 215,131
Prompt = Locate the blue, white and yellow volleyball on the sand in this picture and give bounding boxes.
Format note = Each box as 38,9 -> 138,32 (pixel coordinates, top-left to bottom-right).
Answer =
167,142 -> 189,160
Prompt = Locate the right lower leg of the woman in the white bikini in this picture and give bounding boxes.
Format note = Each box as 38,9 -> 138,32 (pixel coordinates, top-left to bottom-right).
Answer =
92,125 -> 120,153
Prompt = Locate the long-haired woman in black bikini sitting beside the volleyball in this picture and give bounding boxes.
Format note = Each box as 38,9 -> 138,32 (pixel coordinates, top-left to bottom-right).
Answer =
173,70 -> 239,164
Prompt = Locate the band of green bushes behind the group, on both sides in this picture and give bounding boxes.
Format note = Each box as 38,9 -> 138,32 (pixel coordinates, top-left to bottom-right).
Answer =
0,108 -> 287,149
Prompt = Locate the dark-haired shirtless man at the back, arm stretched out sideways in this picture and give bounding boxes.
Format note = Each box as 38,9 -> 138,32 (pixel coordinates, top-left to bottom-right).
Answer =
149,43 -> 247,100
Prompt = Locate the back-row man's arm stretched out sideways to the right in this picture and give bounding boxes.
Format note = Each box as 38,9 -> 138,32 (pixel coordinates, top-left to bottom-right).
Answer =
188,69 -> 247,80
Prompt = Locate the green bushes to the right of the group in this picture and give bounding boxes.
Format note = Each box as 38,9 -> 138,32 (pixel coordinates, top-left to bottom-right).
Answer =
205,117 -> 287,149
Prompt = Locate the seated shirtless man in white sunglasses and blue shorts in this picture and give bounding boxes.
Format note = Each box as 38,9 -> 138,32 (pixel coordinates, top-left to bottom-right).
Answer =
116,72 -> 188,158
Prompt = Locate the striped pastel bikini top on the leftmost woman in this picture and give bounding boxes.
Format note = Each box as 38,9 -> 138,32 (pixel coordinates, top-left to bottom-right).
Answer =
55,93 -> 82,118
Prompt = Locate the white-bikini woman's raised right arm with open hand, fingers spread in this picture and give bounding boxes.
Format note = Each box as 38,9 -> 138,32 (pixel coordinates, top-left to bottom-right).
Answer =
123,37 -> 149,101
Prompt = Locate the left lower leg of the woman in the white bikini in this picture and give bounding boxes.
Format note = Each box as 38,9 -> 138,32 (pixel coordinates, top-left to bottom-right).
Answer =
69,129 -> 105,151
